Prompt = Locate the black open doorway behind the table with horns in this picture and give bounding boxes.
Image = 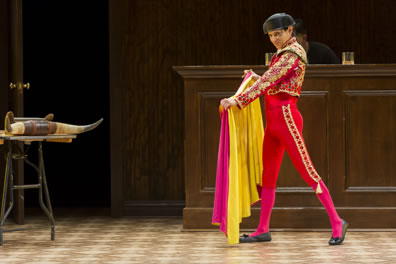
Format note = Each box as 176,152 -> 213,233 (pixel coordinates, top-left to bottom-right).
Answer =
23,0 -> 110,207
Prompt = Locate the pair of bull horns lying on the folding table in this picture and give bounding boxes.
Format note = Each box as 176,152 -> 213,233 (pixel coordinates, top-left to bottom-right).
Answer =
4,111 -> 103,136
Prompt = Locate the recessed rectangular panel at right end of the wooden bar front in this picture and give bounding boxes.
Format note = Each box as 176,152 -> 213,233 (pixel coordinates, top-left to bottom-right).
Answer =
345,92 -> 396,191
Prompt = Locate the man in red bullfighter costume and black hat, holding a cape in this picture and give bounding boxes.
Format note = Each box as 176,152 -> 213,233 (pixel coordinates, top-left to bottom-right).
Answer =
221,13 -> 348,245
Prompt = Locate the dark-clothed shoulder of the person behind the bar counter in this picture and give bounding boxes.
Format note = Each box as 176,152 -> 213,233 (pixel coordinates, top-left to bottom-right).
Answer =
307,41 -> 341,64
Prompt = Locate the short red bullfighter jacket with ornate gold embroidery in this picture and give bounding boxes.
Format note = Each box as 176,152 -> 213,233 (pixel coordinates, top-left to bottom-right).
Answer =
234,37 -> 307,108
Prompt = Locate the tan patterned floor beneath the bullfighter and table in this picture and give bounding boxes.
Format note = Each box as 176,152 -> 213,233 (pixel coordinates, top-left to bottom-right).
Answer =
0,217 -> 396,264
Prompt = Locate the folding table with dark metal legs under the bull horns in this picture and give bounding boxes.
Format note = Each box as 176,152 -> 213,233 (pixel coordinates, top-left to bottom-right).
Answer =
0,130 -> 77,245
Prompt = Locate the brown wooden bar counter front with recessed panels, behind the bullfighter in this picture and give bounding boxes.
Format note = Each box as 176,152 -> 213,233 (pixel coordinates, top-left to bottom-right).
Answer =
174,65 -> 396,229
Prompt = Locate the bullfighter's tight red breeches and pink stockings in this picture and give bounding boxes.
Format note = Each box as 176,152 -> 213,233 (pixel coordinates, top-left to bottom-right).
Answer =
250,93 -> 342,237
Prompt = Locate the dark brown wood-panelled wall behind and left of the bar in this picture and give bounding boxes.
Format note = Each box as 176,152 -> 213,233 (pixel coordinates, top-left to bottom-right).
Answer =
110,0 -> 396,214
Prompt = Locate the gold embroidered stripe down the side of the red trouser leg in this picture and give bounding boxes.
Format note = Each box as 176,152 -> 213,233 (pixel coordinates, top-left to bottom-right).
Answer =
282,105 -> 321,183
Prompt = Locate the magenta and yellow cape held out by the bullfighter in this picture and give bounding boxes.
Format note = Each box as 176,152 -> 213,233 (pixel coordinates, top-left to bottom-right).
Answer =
212,72 -> 264,244
